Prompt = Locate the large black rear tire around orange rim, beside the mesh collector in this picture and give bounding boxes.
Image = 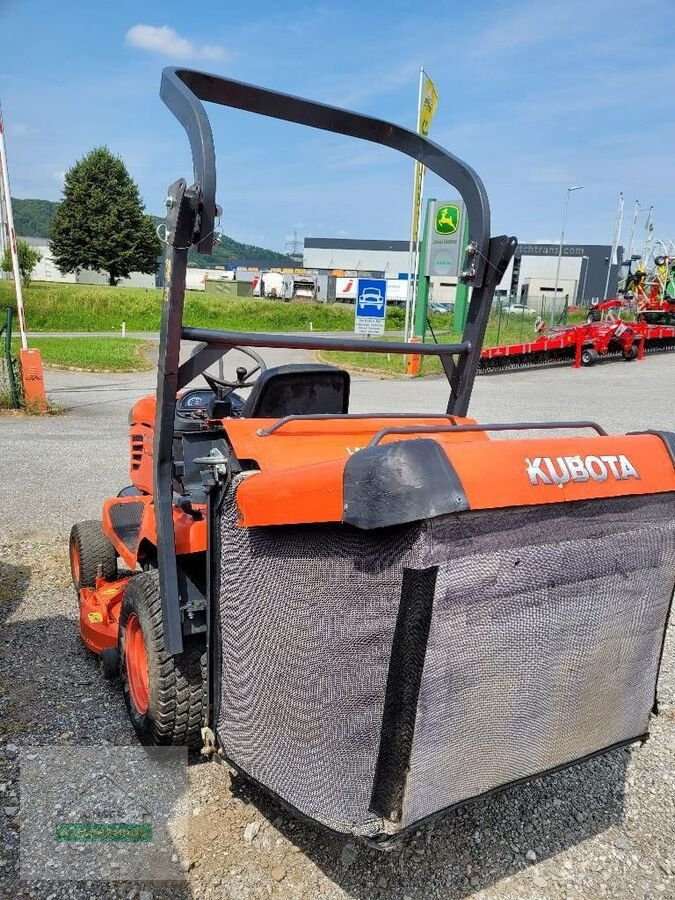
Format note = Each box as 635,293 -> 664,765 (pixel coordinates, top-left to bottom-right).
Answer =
119,572 -> 206,749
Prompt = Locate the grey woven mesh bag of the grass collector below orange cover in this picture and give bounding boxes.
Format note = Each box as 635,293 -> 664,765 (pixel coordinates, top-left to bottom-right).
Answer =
217,475 -> 675,837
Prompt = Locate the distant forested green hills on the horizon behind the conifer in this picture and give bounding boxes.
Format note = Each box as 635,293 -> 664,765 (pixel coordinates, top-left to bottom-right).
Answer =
12,199 -> 298,268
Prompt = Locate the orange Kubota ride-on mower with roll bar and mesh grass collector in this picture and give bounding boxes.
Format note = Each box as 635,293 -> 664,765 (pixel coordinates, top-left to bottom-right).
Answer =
71,69 -> 675,844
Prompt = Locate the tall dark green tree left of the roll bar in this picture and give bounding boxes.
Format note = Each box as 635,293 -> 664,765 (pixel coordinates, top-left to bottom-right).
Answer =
50,147 -> 161,285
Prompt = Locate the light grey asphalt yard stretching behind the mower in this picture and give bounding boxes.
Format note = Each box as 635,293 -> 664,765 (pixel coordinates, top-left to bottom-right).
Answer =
0,350 -> 675,536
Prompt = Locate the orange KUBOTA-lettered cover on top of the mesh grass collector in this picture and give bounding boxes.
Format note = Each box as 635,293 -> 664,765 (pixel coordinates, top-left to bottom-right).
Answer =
237,432 -> 675,527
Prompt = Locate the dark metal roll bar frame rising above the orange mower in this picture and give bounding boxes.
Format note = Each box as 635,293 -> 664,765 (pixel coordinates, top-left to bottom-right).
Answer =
154,68 -> 517,654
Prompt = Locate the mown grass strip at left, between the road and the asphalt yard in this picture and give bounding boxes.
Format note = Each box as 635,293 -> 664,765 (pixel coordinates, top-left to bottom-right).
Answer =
12,337 -> 152,372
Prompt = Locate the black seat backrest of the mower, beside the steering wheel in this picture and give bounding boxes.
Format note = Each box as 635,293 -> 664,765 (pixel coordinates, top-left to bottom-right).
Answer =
241,363 -> 350,419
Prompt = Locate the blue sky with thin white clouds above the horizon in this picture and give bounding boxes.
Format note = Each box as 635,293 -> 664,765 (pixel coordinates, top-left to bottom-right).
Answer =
0,0 -> 675,249
